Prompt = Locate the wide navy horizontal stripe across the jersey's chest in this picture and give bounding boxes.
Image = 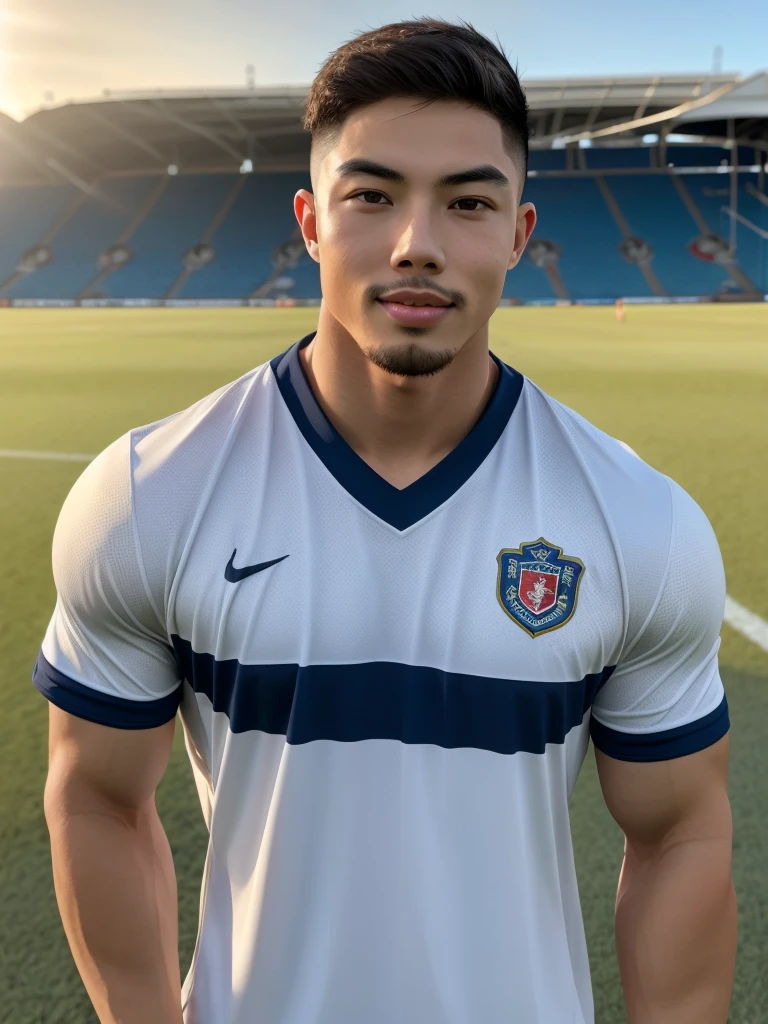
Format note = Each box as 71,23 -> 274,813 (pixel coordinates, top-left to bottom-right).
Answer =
172,636 -> 613,754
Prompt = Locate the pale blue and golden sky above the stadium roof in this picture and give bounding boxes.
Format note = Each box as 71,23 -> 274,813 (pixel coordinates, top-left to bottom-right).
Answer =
0,0 -> 768,119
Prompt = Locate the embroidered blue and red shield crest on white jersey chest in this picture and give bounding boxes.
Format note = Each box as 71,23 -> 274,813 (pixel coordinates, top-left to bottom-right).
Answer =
496,537 -> 584,637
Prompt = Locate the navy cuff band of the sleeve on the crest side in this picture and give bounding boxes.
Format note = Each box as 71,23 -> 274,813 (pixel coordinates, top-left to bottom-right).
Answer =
590,694 -> 730,761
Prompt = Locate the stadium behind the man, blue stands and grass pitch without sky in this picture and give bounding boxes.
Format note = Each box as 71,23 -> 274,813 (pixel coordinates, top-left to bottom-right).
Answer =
0,61 -> 768,1024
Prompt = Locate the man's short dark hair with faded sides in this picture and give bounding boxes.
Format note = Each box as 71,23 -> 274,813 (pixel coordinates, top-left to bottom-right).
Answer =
303,17 -> 530,184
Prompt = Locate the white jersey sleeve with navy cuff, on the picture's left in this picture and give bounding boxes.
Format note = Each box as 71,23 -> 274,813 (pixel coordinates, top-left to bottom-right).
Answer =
32,434 -> 181,729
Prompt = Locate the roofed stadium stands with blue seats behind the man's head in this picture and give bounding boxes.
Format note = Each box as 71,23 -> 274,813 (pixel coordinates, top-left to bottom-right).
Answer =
0,73 -> 768,306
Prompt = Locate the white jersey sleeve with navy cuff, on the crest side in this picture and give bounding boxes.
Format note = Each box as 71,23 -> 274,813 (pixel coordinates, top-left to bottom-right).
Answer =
590,480 -> 729,761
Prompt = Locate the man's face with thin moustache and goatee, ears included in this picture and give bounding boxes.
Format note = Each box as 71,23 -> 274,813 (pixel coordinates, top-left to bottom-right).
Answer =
294,98 -> 536,376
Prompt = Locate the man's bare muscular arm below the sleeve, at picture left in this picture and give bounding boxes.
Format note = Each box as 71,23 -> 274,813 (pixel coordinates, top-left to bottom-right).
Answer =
44,705 -> 182,1024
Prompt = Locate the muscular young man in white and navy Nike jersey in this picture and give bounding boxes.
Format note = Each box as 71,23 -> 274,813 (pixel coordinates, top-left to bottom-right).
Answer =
34,19 -> 735,1024
